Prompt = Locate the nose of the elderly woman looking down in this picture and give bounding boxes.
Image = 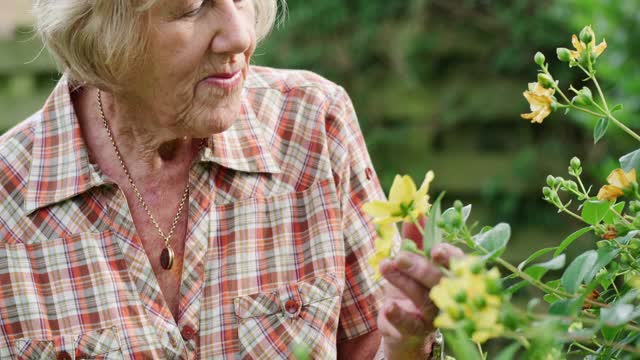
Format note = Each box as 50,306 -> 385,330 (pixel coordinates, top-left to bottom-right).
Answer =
211,0 -> 255,55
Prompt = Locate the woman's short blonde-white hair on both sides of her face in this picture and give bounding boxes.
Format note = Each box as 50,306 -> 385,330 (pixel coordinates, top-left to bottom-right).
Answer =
33,0 -> 285,90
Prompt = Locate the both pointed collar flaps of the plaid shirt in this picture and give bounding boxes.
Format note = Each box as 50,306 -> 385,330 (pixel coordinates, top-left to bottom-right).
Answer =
24,76 -> 280,214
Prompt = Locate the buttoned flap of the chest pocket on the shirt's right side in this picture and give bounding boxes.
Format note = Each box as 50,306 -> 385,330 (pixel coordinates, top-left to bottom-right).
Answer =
233,274 -> 340,319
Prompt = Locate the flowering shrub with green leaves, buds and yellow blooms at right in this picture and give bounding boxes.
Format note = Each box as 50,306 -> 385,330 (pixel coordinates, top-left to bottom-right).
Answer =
364,26 -> 640,359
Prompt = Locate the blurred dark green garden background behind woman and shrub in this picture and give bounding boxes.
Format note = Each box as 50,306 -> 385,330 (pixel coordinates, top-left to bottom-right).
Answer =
0,0 -> 640,261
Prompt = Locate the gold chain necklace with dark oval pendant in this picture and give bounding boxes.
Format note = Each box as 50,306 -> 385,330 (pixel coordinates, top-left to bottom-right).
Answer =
98,90 -> 189,270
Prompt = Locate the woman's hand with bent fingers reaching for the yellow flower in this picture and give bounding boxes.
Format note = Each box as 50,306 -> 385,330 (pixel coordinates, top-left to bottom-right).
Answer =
378,243 -> 464,359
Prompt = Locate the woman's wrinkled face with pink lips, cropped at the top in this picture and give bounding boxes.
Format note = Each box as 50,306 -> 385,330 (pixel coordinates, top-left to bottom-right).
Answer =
122,0 -> 256,138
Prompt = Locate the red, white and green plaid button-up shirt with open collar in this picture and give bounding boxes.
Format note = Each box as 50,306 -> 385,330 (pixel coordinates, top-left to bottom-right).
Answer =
0,67 -> 384,359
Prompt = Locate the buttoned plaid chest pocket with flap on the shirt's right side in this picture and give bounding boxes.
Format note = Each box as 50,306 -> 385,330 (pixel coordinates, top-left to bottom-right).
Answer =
234,275 -> 341,359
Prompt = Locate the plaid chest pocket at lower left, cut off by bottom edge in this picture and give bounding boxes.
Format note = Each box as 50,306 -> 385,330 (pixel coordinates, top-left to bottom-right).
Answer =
12,328 -> 123,360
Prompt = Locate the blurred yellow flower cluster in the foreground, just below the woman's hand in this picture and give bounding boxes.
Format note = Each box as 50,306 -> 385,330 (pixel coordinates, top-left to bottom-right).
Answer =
429,256 -> 504,343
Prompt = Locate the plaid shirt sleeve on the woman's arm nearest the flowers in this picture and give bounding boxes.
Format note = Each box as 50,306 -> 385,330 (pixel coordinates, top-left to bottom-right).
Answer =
326,87 -> 384,342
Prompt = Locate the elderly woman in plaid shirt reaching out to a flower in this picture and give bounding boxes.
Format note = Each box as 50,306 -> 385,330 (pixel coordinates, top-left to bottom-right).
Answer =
0,0 -> 459,359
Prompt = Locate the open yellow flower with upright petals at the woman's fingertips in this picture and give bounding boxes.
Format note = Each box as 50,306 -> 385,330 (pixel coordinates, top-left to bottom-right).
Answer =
362,171 -> 434,224
